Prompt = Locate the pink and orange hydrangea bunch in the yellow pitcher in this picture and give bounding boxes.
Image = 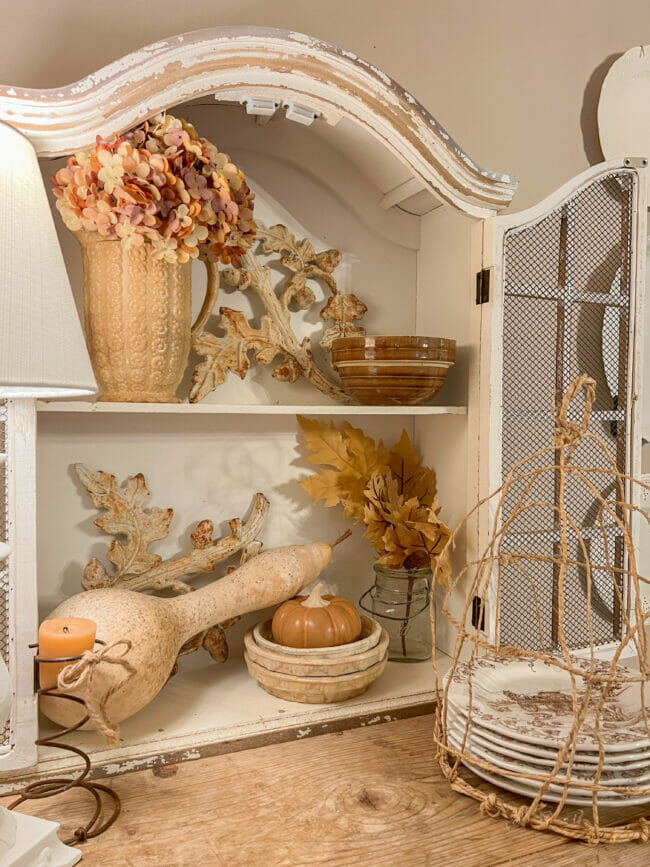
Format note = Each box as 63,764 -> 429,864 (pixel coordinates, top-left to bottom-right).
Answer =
52,114 -> 255,265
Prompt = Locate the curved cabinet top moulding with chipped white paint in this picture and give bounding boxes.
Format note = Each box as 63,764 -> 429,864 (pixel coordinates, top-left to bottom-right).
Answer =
0,27 -> 517,217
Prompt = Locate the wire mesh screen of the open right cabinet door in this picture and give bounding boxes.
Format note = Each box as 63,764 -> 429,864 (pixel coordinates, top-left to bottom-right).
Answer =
499,169 -> 636,650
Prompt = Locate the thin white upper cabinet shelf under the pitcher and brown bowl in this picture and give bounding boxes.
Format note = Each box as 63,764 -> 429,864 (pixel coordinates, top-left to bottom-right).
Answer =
38,400 -> 467,416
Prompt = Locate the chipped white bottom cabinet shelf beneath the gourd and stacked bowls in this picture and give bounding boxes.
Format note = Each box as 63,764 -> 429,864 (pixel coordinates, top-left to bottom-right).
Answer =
0,652 -> 451,794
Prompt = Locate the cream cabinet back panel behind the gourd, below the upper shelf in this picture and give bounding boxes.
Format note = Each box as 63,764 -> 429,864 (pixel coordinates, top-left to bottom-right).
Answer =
37,413 -> 408,654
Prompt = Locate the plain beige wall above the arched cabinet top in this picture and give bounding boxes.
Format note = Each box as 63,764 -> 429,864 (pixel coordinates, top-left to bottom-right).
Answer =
0,0 -> 650,209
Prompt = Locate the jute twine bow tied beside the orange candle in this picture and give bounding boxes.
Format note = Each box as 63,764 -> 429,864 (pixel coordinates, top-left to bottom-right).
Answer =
57,639 -> 136,747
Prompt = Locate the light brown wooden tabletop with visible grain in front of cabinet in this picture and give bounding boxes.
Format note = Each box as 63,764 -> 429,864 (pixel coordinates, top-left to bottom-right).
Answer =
4,717 -> 650,867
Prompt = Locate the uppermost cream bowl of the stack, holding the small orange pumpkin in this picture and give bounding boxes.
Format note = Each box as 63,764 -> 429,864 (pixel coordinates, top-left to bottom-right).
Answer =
244,629 -> 388,677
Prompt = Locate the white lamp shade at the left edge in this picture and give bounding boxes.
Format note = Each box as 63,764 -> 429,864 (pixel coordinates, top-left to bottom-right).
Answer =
0,123 -> 97,398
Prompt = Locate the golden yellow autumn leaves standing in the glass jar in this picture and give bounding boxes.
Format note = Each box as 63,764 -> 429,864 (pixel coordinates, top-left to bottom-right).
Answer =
298,416 -> 451,583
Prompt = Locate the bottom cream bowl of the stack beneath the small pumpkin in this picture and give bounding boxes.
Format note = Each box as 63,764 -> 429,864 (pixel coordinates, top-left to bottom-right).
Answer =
244,653 -> 387,704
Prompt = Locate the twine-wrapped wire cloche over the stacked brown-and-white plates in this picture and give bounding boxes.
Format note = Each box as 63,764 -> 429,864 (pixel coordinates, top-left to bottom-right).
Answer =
431,375 -> 650,844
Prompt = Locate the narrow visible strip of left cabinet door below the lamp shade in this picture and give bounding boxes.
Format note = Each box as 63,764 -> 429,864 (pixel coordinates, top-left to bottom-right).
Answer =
0,400 -> 38,777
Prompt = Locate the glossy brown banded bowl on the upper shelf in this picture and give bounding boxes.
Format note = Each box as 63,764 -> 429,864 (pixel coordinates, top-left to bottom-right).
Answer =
332,335 -> 456,406
